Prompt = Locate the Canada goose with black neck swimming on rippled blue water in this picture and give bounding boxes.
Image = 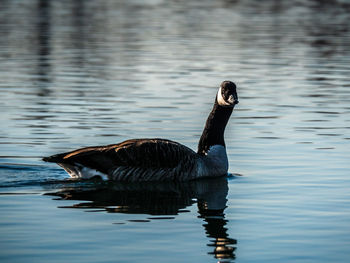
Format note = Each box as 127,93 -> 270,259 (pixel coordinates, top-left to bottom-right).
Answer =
43,80 -> 238,182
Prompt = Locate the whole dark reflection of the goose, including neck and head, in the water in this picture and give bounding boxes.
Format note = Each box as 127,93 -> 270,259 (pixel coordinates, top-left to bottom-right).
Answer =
47,177 -> 236,259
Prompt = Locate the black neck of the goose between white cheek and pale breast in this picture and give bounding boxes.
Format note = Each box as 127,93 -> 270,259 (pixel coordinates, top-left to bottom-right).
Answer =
197,99 -> 233,155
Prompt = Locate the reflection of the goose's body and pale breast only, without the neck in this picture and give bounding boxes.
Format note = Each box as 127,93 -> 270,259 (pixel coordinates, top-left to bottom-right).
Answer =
48,177 -> 228,215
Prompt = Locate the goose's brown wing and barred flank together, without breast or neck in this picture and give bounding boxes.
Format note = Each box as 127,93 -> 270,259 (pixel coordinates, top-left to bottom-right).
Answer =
44,138 -> 199,181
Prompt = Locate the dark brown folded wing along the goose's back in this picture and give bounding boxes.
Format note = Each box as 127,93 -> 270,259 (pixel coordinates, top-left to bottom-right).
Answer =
43,139 -> 196,173
